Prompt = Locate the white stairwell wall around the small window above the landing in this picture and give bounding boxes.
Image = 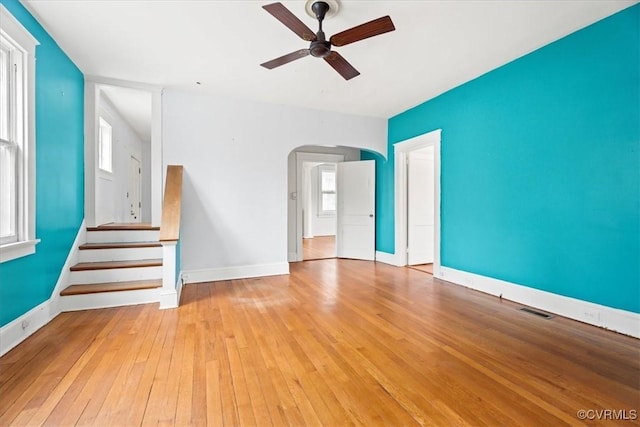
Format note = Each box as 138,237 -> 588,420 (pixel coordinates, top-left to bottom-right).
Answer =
96,94 -> 149,225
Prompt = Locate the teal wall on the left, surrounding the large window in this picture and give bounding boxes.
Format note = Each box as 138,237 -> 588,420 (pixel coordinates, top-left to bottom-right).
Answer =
0,0 -> 84,326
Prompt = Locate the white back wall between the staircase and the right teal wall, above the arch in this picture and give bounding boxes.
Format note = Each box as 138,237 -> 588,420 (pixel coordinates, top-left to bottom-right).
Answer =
162,89 -> 387,278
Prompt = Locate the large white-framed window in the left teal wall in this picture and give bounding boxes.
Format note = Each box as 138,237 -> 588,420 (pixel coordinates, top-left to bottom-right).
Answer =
0,5 -> 38,262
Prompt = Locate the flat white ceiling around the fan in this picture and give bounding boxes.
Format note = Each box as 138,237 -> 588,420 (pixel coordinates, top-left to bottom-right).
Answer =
22,0 -> 637,129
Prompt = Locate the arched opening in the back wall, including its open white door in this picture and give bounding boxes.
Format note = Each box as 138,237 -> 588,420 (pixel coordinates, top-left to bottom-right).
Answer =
288,146 -> 375,262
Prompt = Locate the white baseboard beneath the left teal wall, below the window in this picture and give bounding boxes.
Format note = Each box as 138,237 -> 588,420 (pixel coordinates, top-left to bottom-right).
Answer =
0,300 -> 59,357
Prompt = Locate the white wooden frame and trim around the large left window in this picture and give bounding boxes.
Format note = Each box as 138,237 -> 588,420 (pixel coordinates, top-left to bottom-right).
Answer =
0,4 -> 40,263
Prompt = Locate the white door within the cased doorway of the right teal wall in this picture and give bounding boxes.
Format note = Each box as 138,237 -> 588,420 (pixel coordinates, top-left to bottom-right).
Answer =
407,146 -> 435,265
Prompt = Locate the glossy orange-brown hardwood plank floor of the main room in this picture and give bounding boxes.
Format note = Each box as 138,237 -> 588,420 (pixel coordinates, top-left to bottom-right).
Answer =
0,259 -> 640,426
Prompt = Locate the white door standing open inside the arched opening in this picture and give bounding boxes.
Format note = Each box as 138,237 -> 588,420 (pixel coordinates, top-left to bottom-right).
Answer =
336,160 -> 376,261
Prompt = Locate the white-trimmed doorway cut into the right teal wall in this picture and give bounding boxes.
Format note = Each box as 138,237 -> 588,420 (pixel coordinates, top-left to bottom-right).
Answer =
394,130 -> 441,277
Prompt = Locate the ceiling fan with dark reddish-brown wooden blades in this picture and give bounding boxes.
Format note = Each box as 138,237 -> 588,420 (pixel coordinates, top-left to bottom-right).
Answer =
260,1 -> 396,80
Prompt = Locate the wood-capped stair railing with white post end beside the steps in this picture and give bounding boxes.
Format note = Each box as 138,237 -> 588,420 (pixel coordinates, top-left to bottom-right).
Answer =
160,165 -> 183,308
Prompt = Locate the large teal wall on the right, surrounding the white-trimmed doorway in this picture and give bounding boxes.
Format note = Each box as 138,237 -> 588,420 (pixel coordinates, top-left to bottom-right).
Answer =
377,5 -> 640,313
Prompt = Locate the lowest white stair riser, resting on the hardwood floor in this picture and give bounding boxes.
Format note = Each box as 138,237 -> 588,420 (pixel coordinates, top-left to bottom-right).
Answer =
59,288 -> 160,311
